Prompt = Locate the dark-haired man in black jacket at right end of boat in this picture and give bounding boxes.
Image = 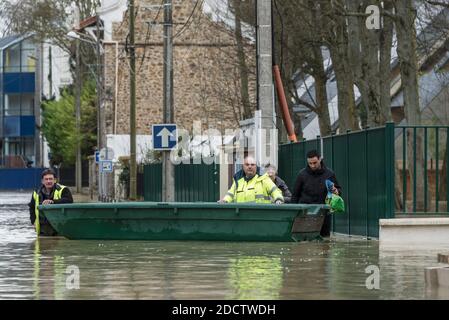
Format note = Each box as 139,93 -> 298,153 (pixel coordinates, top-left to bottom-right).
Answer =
292,150 -> 341,237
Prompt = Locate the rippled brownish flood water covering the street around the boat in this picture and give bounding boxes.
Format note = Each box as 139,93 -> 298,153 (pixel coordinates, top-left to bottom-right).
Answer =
0,192 -> 449,299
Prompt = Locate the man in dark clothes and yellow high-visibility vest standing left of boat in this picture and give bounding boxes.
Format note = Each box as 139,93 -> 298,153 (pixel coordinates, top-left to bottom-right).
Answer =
28,169 -> 73,236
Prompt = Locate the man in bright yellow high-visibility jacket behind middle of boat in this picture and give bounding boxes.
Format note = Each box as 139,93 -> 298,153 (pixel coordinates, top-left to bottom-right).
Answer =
218,156 -> 284,204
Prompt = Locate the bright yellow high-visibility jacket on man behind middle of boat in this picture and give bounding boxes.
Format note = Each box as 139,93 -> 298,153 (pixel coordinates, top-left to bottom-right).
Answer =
223,174 -> 284,203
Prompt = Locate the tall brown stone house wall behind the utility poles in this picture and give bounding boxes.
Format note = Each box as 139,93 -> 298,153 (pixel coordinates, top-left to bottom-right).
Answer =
99,0 -> 256,142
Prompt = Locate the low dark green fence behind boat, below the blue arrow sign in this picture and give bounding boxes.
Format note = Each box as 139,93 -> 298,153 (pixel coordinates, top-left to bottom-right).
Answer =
144,164 -> 220,202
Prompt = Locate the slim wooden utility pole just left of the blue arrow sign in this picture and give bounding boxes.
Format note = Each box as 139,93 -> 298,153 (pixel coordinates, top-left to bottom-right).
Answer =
128,0 -> 137,200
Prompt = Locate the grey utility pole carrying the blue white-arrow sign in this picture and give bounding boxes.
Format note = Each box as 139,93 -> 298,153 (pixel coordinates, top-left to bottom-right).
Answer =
162,0 -> 175,202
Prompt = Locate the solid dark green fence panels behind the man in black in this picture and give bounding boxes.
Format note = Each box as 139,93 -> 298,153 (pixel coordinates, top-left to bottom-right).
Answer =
279,128 -> 391,237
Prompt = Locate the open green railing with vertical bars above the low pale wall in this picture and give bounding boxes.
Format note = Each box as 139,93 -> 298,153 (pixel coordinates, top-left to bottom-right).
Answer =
395,126 -> 449,216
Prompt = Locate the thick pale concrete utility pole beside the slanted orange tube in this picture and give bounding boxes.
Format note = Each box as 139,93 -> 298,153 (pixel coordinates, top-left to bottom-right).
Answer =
256,0 -> 277,168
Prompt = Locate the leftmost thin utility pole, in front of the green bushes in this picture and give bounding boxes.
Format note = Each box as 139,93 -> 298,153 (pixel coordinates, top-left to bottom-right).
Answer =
75,39 -> 82,193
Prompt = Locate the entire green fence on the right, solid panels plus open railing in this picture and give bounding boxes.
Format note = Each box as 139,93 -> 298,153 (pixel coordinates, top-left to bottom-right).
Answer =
279,123 -> 449,237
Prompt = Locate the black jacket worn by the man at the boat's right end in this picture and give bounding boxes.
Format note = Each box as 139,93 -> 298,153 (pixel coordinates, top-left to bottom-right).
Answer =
291,161 -> 341,204
